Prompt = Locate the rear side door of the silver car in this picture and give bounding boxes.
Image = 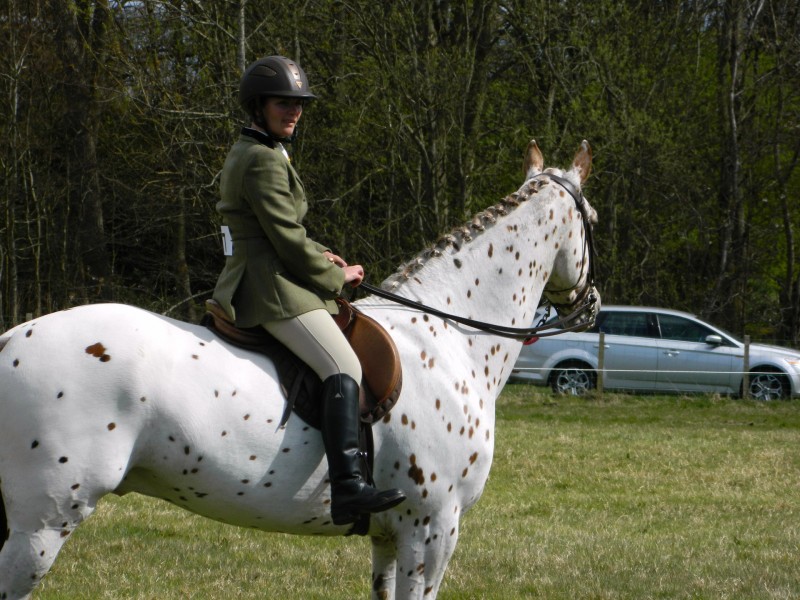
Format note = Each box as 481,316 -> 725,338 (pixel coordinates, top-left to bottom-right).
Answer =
592,311 -> 659,390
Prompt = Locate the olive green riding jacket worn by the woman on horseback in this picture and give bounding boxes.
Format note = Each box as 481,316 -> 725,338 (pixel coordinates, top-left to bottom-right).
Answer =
214,130 -> 344,327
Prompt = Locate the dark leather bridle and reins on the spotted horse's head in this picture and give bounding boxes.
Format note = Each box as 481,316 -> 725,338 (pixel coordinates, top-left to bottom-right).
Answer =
359,173 -> 598,341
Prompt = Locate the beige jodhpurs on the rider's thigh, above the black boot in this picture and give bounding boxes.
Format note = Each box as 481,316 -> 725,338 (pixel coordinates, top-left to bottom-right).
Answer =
261,309 -> 361,384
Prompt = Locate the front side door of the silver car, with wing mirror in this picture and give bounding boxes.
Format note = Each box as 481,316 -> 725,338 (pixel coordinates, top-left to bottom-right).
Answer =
656,314 -> 741,392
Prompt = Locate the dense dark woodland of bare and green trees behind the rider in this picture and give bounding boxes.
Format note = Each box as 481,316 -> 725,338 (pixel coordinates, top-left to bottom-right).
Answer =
0,0 -> 800,345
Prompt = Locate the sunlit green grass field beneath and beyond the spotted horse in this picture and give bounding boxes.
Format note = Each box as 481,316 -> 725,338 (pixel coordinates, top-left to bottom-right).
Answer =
34,385 -> 800,600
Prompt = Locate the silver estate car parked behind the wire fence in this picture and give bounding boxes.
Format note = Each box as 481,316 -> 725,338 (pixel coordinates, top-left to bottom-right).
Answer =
511,306 -> 800,400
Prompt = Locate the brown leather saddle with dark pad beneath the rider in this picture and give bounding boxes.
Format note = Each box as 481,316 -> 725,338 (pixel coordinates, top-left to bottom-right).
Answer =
200,298 -> 403,429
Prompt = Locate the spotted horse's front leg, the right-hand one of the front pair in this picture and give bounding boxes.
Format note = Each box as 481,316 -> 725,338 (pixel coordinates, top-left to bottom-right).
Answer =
395,511 -> 459,600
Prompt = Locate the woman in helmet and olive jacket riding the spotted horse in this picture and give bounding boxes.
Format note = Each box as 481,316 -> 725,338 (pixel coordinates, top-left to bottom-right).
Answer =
214,56 -> 405,525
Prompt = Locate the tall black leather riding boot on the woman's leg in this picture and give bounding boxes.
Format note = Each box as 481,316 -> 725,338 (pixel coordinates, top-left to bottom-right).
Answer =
322,374 -> 406,525
